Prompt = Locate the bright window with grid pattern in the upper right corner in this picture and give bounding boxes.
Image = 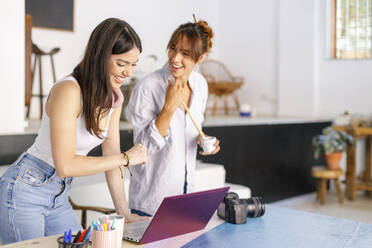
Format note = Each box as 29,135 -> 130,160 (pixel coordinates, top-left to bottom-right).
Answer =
328,0 -> 372,59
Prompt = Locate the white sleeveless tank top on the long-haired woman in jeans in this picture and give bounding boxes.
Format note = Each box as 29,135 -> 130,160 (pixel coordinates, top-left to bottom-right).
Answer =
27,76 -> 113,167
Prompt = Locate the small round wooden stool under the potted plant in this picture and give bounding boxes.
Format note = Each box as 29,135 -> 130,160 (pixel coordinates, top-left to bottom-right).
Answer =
311,166 -> 344,204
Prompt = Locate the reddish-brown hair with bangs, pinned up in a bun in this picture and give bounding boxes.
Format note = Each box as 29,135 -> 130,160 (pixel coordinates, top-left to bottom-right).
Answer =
167,20 -> 214,62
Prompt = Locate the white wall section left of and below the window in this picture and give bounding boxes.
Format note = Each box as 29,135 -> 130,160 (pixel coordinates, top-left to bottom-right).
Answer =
316,0 -> 372,116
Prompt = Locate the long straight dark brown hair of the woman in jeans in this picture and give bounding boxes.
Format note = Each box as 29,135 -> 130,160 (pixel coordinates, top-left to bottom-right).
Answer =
72,18 -> 142,138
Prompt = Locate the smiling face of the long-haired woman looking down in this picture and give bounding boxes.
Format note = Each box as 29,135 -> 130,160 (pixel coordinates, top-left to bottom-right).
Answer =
109,47 -> 140,88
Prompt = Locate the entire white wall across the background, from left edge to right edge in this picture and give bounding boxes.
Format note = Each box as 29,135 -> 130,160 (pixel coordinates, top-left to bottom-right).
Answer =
0,0 -> 372,132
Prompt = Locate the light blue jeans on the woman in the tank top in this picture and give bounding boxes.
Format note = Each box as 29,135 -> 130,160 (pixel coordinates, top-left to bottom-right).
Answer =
0,153 -> 82,245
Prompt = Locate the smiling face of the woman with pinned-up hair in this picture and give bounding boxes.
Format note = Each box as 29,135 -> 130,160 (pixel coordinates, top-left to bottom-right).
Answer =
168,36 -> 201,78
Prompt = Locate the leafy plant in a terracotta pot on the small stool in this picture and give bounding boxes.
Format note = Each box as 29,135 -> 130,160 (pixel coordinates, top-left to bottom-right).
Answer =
313,126 -> 354,170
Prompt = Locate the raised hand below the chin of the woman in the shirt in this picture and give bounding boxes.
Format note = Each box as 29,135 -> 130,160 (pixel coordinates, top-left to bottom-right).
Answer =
164,79 -> 186,113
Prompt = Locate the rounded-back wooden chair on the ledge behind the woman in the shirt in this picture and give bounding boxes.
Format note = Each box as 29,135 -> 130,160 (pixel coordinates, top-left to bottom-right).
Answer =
200,60 -> 244,115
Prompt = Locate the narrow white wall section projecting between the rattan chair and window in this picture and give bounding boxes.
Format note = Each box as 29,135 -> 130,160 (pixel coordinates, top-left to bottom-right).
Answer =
278,0 -> 316,116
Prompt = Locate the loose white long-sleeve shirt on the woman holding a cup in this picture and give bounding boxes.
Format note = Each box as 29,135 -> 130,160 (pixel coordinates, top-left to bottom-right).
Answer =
128,64 -> 208,215
